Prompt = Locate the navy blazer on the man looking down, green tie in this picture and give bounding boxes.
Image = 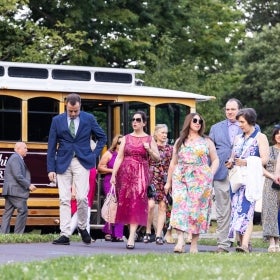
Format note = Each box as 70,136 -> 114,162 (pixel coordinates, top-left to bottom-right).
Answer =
47,111 -> 107,174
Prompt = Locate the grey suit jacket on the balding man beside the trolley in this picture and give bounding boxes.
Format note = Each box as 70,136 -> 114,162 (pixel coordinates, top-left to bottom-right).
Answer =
2,153 -> 31,199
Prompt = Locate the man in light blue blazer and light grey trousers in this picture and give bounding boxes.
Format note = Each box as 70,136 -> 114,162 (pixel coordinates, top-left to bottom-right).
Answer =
209,98 -> 242,252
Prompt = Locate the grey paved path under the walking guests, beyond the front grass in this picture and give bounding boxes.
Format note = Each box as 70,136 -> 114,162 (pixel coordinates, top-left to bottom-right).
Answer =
0,239 -> 266,265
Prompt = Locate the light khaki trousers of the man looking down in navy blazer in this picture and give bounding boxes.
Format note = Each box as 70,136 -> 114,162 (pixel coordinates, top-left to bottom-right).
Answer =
57,157 -> 89,237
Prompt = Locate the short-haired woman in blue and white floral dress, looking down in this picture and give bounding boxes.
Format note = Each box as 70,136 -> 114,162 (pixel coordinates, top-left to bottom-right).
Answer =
226,108 -> 269,253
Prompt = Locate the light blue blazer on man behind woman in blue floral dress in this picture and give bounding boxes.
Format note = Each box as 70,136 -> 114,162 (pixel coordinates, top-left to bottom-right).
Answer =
209,120 -> 242,181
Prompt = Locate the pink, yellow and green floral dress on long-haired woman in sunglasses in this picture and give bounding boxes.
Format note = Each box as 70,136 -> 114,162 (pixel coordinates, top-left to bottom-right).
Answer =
170,137 -> 213,234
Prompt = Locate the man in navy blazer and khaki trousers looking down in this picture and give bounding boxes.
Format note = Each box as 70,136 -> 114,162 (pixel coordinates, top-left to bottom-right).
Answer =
47,93 -> 107,245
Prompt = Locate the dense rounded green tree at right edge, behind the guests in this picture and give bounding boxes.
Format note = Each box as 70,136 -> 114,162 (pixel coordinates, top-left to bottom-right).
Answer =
224,24 -> 280,128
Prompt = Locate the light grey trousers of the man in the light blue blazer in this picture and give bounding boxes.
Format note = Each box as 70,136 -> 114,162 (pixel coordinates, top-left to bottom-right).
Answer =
214,177 -> 231,250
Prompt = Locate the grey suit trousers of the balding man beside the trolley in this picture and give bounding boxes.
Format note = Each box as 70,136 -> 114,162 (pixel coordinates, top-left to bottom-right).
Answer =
1,196 -> 28,234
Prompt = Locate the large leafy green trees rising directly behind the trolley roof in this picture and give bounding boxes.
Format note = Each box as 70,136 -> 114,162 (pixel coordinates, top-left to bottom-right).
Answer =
0,0 -> 262,130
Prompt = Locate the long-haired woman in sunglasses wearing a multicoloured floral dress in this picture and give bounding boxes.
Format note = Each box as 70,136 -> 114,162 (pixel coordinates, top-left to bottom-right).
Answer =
164,113 -> 219,253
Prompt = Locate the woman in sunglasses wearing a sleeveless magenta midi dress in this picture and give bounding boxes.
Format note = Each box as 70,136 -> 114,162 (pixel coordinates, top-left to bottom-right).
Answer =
111,111 -> 160,249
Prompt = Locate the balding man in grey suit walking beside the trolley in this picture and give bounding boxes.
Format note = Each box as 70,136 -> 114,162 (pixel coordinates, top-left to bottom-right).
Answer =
1,142 -> 36,234
